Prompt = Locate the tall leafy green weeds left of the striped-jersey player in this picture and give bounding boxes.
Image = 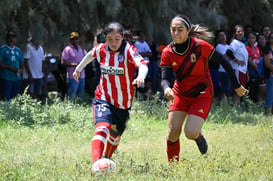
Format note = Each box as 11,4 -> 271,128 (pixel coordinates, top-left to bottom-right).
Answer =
0,94 -> 92,129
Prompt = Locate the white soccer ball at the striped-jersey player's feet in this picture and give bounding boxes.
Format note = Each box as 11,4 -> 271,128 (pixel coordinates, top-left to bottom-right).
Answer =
92,158 -> 116,175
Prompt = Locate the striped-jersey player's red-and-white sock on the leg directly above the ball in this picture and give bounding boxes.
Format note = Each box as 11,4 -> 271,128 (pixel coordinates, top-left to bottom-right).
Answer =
91,122 -> 111,162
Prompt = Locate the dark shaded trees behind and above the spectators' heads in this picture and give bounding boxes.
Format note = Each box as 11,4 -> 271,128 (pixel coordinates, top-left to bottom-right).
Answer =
0,0 -> 273,55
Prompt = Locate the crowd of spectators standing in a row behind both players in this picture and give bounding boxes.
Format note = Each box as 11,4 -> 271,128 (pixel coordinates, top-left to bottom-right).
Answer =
0,25 -> 273,114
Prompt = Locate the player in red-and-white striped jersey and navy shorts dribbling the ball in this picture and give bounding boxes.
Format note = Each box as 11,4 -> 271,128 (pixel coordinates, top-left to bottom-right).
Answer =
73,22 -> 148,167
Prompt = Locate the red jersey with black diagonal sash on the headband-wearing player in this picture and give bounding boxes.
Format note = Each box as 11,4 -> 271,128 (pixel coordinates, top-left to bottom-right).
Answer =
160,37 -> 214,97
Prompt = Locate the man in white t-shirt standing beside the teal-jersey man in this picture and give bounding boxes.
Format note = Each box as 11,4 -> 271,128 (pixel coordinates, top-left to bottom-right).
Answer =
22,36 -> 45,99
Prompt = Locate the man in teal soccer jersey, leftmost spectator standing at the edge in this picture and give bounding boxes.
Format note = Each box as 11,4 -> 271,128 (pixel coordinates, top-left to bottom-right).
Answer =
0,31 -> 24,101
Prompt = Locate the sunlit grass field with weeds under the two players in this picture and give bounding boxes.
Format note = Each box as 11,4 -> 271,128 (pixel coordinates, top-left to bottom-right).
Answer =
0,96 -> 273,181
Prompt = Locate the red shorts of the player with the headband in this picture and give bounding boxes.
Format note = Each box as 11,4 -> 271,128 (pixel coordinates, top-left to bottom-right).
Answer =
169,94 -> 212,120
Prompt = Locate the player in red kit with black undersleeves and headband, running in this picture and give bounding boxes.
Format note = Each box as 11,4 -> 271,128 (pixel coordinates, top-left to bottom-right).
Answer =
160,15 -> 248,161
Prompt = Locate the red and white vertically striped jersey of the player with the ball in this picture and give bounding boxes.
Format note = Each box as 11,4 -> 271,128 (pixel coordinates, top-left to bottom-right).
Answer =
91,41 -> 145,109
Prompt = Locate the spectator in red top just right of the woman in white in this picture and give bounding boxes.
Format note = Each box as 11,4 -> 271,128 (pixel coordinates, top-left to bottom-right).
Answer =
246,31 -> 261,103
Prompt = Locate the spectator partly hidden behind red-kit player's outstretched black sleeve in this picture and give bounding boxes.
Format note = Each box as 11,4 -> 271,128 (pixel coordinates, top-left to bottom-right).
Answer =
215,30 -> 232,99
